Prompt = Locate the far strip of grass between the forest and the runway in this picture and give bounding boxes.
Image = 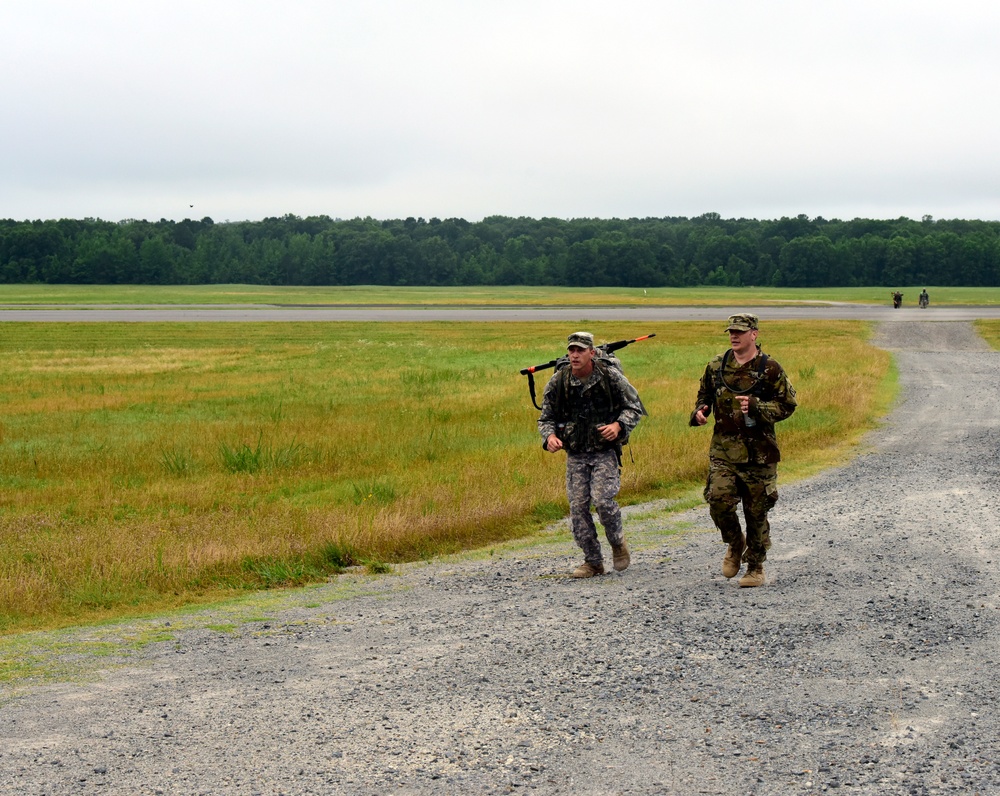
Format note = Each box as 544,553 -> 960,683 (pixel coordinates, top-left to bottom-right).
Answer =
0,285 -> 1000,306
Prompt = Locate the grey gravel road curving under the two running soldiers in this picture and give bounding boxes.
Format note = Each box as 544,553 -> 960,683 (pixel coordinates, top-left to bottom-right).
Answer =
0,321 -> 1000,795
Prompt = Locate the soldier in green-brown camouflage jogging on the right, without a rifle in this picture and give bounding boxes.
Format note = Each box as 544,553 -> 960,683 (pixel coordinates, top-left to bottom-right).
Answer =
691,313 -> 797,587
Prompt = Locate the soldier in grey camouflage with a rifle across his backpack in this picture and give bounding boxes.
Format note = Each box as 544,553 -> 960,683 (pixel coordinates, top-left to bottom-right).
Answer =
538,332 -> 645,578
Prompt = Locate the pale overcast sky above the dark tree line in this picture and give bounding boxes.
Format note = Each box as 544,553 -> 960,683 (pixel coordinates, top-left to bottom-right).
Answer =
0,0 -> 1000,221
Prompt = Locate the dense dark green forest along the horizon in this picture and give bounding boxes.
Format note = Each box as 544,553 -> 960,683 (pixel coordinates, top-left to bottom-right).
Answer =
0,213 -> 1000,287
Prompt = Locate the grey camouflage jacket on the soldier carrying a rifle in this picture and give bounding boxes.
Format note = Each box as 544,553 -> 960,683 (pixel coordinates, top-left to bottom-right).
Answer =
538,359 -> 646,453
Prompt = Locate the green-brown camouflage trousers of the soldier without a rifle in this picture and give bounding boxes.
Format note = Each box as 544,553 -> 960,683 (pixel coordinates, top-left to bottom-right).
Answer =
705,459 -> 778,566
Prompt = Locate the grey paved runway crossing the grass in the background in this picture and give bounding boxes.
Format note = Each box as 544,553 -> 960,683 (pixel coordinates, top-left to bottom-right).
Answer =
0,304 -> 1000,323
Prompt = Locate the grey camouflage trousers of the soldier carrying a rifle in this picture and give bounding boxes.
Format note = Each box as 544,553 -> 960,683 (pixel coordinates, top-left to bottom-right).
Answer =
566,450 -> 625,566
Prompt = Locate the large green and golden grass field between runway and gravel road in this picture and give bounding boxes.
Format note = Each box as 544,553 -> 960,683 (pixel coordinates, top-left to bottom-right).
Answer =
0,322 -> 894,633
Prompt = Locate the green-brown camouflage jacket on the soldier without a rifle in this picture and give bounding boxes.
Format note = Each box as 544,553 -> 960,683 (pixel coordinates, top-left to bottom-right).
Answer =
691,346 -> 798,464
